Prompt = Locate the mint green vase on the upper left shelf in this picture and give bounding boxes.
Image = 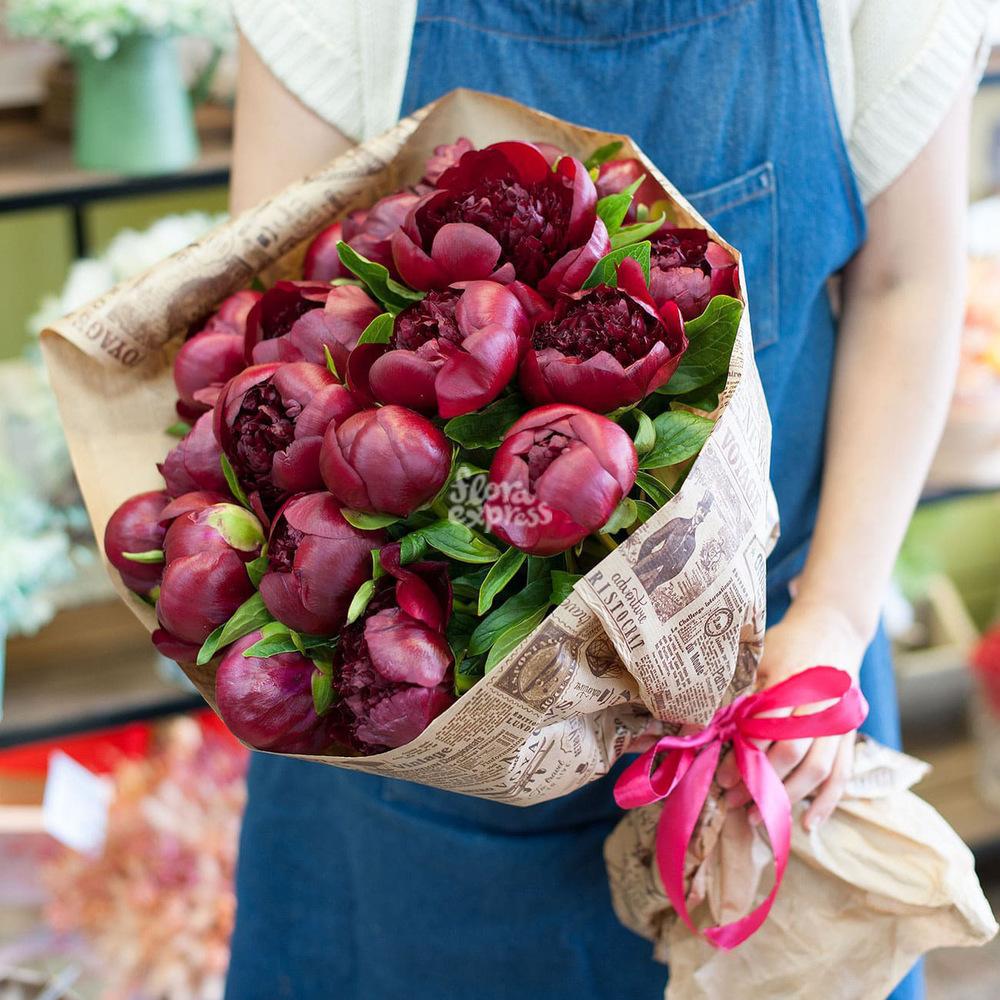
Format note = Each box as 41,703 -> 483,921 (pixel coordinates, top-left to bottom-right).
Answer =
73,35 -> 198,174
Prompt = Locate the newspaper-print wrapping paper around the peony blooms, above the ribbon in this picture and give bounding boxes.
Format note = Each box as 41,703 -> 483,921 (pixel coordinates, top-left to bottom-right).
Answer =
43,91 -> 777,805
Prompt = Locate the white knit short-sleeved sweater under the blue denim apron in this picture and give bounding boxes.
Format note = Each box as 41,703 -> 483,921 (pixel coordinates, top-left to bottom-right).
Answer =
232,0 -> 993,203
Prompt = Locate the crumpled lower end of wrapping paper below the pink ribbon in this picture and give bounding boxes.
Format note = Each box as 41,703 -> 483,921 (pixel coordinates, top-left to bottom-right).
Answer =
604,740 -> 997,1000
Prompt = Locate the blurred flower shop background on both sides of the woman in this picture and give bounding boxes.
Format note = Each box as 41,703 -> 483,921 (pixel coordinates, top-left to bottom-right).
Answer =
0,0 -> 1000,1000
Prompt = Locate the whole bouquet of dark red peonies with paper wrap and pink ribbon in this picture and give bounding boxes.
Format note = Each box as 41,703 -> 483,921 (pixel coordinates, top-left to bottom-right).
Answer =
42,91 -> 995,997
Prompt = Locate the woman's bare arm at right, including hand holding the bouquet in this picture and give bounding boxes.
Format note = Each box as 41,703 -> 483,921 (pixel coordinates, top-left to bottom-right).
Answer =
720,68 -> 974,828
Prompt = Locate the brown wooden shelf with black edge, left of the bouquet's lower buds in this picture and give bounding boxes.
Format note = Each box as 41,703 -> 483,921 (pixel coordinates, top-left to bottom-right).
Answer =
0,598 -> 204,748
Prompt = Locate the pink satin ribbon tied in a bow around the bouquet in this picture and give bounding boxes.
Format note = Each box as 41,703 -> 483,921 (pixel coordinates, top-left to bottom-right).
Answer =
615,667 -> 868,951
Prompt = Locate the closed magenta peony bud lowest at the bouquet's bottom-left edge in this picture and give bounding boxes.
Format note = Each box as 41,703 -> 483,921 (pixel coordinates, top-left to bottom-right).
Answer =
215,631 -> 350,754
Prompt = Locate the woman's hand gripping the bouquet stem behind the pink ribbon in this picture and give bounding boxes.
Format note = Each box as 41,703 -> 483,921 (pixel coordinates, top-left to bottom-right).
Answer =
718,600 -> 867,830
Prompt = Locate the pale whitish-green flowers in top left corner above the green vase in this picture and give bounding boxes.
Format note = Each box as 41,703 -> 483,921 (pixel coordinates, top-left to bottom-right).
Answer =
6,0 -> 234,59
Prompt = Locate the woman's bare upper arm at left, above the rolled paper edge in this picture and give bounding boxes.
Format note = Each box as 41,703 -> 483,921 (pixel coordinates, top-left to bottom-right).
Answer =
229,35 -> 354,215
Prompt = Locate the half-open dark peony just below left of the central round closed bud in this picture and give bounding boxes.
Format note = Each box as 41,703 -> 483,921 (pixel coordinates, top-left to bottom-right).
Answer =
260,493 -> 385,635
